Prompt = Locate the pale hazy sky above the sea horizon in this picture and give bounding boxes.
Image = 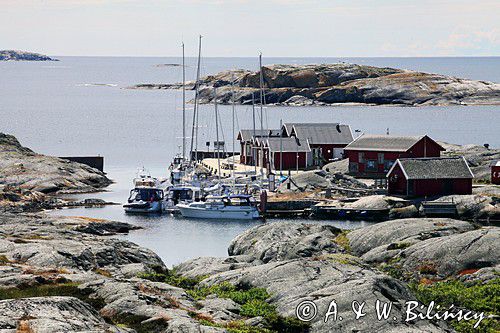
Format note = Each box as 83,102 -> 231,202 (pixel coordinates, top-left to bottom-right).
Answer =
0,0 -> 500,57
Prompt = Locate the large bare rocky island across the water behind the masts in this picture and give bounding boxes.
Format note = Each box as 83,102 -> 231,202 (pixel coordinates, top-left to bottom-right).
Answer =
130,63 -> 500,106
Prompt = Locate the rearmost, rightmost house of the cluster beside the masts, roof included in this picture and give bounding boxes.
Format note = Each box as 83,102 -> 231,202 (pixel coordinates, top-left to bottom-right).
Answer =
282,123 -> 353,165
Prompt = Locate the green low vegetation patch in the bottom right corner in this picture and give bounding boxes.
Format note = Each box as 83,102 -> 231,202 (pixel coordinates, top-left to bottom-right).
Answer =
410,278 -> 500,333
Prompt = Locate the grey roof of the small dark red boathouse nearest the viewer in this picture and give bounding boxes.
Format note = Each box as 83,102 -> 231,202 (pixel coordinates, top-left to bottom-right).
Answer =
388,157 -> 474,179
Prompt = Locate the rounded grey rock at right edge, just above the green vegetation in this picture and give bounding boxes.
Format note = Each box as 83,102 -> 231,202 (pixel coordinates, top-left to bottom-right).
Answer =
347,219 -> 500,279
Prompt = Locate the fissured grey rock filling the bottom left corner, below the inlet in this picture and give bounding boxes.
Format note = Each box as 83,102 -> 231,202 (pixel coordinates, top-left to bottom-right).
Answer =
0,214 -> 229,333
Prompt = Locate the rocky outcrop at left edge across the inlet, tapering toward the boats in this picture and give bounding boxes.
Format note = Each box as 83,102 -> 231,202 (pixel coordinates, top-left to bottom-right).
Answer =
0,133 -> 111,210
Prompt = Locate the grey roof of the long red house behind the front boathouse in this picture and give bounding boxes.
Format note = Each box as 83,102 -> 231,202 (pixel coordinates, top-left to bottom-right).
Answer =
344,134 -> 444,152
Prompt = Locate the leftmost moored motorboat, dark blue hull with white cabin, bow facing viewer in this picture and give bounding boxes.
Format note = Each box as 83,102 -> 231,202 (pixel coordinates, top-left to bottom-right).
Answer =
123,169 -> 167,214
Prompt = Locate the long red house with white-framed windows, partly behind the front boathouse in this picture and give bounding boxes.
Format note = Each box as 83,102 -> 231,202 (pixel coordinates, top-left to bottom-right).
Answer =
344,134 -> 445,178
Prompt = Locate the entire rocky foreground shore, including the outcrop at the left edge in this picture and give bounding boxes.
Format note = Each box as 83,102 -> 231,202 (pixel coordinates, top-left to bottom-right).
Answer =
0,134 -> 500,333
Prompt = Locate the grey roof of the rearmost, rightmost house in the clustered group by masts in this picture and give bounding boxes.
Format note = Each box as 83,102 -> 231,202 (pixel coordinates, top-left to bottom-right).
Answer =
284,123 -> 353,145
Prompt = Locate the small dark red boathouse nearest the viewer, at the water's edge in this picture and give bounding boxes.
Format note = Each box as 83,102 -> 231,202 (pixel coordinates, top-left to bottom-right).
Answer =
387,157 -> 474,197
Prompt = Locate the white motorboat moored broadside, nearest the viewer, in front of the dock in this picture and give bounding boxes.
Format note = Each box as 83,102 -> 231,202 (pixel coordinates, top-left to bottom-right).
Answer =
177,195 -> 260,220
